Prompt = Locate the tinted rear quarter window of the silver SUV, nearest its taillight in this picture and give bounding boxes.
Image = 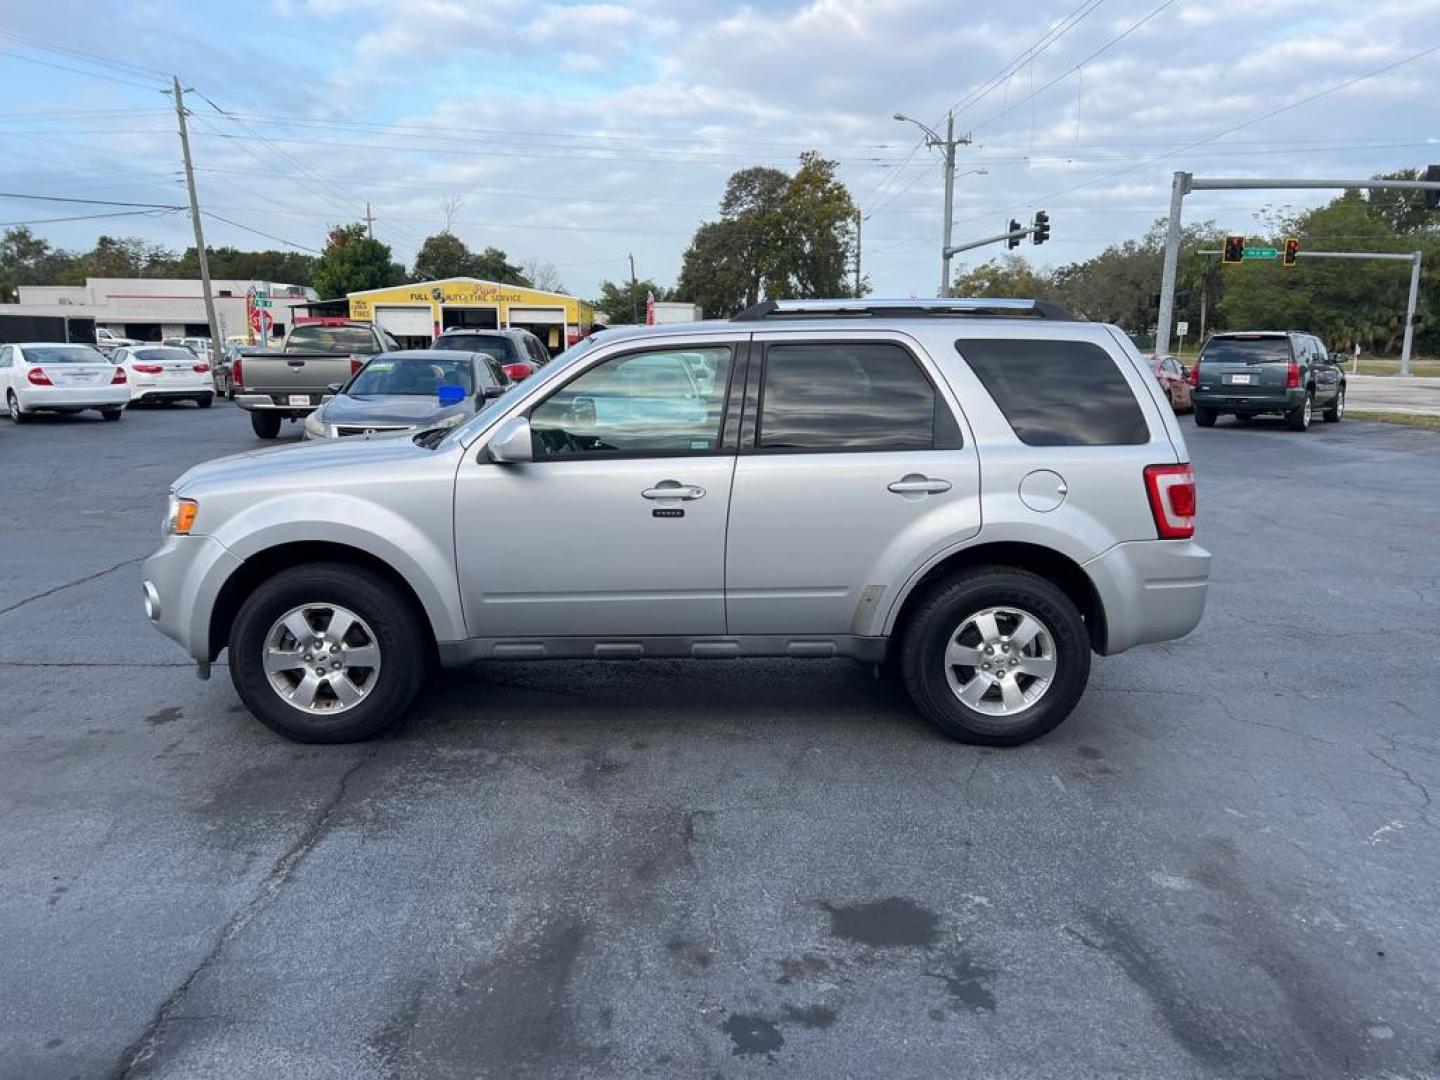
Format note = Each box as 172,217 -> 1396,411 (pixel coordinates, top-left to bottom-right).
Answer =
955,338 -> 1151,446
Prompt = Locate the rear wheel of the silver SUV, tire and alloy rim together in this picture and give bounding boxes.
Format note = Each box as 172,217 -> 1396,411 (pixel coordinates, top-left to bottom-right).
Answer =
900,566 -> 1090,746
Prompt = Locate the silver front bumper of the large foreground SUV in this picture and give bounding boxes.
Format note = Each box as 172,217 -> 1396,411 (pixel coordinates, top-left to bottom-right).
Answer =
141,536 -> 242,662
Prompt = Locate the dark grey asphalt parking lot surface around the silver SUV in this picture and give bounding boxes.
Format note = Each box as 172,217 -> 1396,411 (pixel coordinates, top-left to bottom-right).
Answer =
0,403 -> 1440,1080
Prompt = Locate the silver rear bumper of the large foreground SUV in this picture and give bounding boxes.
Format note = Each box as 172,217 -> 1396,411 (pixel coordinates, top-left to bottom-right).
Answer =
1084,540 -> 1210,655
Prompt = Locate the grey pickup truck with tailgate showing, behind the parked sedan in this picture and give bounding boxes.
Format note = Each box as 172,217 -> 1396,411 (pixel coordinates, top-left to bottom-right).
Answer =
230,323 -> 400,439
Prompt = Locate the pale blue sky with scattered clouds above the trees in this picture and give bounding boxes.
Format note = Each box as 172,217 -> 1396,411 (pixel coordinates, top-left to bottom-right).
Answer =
0,0 -> 1440,295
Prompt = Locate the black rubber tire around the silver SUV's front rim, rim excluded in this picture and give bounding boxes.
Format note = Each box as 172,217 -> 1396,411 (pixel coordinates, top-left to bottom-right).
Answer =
229,563 -> 429,743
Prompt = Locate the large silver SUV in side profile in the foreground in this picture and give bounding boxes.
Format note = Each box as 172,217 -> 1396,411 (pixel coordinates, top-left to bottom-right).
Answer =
144,300 -> 1210,744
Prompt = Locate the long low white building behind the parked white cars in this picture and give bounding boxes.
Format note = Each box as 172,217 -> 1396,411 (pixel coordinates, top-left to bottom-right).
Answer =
0,278 -> 320,341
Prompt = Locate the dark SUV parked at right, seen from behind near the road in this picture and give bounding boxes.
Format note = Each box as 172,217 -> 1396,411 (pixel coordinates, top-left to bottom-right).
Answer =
1189,331 -> 1345,431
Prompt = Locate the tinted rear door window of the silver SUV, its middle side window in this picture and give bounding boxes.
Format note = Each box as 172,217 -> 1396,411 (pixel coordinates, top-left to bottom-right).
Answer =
756,341 -> 960,454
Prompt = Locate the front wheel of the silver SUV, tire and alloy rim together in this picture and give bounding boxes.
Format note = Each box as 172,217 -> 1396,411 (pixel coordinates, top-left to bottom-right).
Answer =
229,563 -> 428,743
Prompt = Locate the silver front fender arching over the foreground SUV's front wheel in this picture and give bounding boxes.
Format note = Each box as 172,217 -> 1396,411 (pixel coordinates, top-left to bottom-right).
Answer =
215,491 -> 465,641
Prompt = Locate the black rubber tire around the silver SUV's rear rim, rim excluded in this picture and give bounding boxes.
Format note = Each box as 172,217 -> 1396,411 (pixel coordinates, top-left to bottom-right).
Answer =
901,566 -> 1090,746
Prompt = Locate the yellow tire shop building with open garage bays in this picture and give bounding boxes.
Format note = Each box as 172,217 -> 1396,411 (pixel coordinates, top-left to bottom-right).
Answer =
347,278 -> 595,353
